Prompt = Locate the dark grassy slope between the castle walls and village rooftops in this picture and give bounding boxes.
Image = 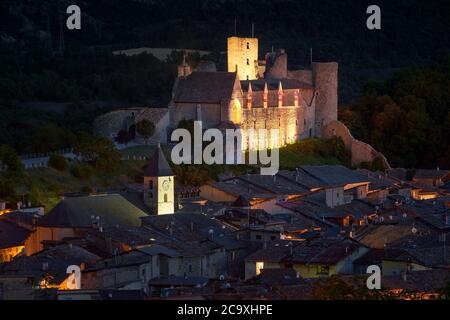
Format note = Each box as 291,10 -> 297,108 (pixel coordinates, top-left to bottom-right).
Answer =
27,139 -> 345,211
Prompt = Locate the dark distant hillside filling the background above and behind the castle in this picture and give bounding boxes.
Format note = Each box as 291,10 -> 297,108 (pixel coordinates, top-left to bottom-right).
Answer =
0,0 -> 450,102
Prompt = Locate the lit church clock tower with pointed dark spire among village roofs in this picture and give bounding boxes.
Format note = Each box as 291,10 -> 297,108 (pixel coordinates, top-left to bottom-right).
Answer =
144,144 -> 175,215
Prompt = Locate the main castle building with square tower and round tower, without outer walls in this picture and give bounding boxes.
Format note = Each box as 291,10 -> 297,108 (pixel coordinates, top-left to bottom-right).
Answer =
169,37 -> 338,149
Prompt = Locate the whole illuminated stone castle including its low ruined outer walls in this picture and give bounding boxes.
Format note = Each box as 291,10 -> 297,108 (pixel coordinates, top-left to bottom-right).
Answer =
94,37 -> 389,168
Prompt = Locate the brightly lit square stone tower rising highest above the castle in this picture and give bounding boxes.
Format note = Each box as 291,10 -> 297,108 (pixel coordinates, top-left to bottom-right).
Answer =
227,37 -> 258,80
